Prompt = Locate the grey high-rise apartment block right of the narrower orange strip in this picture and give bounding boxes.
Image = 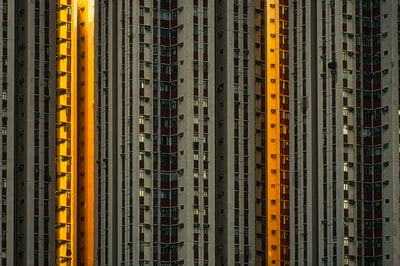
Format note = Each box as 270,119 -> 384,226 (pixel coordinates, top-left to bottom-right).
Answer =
289,0 -> 400,265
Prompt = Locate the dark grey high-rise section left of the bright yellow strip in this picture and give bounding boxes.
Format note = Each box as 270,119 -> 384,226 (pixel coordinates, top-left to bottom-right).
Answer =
12,1 -> 56,265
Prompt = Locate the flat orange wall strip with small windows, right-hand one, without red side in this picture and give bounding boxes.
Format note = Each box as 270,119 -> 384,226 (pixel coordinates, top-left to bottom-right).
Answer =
265,0 -> 280,264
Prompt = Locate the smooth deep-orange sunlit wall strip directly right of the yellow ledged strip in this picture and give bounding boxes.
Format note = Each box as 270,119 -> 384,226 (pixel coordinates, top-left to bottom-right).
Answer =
74,0 -> 94,265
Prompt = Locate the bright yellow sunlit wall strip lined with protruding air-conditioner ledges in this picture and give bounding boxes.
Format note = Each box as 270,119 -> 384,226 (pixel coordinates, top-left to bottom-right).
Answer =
56,0 -> 76,265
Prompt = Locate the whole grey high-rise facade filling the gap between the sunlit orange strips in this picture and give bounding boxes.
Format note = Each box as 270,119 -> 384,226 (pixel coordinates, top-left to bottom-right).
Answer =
95,0 -> 255,265
